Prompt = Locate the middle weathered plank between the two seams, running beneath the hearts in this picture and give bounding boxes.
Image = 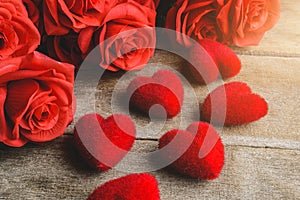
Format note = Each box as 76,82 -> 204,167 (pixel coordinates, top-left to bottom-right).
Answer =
68,51 -> 300,149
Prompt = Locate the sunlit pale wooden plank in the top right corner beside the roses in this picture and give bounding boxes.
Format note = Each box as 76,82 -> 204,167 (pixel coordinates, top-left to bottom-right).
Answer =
234,0 -> 300,57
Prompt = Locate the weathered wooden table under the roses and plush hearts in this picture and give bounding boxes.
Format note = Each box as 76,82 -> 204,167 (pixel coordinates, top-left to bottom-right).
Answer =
0,0 -> 300,199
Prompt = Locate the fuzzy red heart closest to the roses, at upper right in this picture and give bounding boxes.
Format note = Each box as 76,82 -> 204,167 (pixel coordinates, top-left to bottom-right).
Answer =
189,39 -> 241,84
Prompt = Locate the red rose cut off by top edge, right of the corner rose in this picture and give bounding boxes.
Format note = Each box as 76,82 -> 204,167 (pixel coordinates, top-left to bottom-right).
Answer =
43,0 -> 117,35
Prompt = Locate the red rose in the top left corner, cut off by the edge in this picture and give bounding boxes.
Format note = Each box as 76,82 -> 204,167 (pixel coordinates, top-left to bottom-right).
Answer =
0,0 -> 40,60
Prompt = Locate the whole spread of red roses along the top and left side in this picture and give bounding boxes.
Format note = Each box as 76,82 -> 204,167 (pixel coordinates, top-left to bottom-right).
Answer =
0,0 -> 280,146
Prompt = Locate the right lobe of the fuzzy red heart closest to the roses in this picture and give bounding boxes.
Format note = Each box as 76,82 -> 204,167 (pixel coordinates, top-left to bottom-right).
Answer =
199,39 -> 241,79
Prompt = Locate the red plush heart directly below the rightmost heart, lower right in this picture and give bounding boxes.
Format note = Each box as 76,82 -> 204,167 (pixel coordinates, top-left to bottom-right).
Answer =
159,122 -> 224,180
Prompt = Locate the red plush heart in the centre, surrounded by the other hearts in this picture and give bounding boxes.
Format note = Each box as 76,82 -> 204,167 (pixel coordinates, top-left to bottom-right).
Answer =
127,70 -> 184,118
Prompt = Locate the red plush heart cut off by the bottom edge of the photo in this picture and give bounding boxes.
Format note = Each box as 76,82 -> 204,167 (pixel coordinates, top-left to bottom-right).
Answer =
87,173 -> 160,200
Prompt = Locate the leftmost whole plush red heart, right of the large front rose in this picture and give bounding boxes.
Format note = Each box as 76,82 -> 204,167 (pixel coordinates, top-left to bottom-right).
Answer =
74,114 -> 136,171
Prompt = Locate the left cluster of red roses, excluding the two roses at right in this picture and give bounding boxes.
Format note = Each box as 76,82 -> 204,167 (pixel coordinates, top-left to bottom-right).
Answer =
0,0 -> 156,147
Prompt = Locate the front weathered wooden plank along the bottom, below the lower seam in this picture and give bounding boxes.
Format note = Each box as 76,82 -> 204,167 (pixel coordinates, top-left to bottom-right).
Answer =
0,135 -> 300,200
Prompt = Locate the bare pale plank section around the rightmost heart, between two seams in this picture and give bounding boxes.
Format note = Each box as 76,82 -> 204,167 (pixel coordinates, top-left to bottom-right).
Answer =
220,56 -> 300,142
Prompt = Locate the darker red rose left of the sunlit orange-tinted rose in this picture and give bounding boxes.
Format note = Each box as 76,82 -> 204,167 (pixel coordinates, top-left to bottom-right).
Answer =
166,0 -> 222,46
